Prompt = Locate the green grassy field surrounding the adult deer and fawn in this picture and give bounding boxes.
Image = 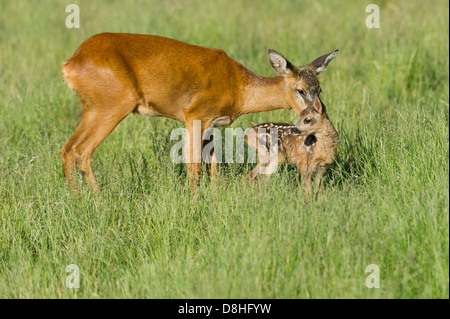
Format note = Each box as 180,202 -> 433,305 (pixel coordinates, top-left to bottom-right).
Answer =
0,0 -> 449,298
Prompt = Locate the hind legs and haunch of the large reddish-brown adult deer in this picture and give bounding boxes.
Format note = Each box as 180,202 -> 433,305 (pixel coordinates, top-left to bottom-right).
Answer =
61,60 -> 144,191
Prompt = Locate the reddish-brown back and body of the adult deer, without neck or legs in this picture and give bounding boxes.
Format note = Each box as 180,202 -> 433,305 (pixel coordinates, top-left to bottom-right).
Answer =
63,33 -> 242,122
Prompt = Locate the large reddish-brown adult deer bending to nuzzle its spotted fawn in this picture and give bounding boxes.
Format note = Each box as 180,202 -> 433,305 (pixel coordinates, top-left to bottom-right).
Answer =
61,33 -> 338,192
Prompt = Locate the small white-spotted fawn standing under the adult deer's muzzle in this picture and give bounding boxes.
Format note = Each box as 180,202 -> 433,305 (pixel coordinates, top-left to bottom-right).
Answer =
247,99 -> 339,196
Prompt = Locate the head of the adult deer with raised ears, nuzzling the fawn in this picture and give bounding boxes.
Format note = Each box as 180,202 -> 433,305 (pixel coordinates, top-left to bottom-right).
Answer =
268,49 -> 339,114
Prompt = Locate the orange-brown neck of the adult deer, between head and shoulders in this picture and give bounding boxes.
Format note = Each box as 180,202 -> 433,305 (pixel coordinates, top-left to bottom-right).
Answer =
240,70 -> 291,114
